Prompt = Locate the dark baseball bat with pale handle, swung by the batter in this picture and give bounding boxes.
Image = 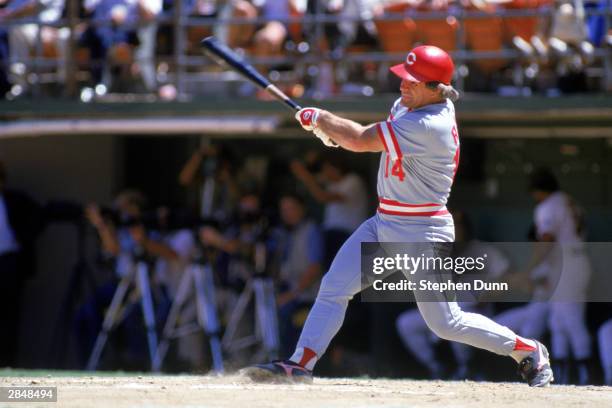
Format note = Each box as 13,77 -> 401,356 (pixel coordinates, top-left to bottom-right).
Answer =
200,37 -> 302,111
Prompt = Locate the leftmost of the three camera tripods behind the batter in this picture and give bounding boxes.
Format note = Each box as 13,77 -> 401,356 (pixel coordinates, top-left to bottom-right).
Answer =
87,247 -> 157,371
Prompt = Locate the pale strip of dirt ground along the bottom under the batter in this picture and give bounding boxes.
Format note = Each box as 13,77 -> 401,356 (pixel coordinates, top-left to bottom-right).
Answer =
0,375 -> 612,408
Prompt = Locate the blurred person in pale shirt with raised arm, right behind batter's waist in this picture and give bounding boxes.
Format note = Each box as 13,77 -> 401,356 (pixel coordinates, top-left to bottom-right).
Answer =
291,154 -> 368,268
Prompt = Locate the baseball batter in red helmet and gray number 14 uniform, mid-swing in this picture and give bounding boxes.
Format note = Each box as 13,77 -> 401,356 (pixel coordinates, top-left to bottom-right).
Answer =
245,46 -> 553,387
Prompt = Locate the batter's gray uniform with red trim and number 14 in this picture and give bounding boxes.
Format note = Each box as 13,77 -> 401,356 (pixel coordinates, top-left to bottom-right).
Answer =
292,99 -> 516,359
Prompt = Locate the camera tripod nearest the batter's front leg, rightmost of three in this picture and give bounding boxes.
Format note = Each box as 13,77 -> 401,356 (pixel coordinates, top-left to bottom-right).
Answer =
222,243 -> 280,361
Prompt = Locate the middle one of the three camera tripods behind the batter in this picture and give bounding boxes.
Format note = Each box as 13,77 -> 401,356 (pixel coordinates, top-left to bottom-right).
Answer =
153,245 -> 223,373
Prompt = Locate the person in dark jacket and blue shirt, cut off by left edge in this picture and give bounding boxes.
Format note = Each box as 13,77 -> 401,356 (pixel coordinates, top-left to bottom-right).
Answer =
0,162 -> 43,367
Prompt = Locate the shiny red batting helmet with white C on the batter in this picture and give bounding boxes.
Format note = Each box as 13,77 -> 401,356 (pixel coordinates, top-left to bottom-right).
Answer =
390,45 -> 455,85
